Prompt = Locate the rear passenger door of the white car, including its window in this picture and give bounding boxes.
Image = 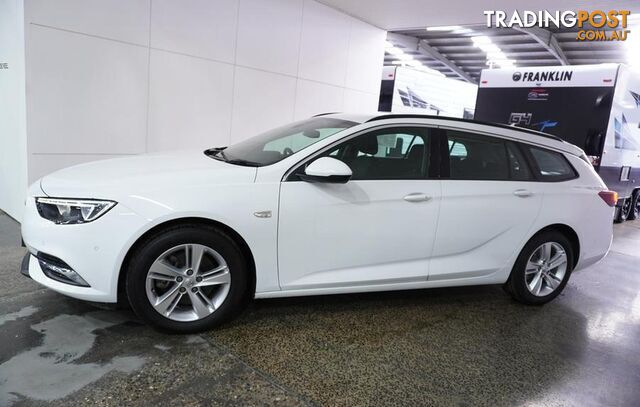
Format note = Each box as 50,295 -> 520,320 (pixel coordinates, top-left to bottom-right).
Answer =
429,128 -> 543,280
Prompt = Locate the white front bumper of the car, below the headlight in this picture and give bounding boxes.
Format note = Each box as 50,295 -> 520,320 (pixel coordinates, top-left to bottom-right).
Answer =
21,194 -> 148,303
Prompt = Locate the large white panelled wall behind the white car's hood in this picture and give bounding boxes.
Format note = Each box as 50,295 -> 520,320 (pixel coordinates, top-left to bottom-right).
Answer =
23,0 -> 385,180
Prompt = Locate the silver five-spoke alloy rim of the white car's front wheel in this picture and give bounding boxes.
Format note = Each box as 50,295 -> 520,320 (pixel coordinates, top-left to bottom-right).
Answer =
146,244 -> 231,322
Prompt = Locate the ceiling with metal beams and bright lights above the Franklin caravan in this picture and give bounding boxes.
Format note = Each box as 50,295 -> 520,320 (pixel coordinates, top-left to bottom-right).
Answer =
319,0 -> 640,83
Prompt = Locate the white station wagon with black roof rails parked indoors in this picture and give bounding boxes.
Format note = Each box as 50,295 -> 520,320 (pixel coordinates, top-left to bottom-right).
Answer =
22,114 -> 617,332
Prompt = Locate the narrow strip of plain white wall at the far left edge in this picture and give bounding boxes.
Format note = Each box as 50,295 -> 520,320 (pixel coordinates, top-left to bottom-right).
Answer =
0,0 -> 27,220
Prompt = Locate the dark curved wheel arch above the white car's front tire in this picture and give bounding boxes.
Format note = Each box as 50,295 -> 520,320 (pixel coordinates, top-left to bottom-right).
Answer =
117,217 -> 256,305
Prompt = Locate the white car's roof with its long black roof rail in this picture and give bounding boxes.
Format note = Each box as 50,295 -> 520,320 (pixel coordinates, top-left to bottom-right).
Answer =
314,112 -> 584,156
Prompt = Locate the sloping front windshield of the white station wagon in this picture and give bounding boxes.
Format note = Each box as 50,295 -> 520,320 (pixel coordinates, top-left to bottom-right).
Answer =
205,117 -> 358,167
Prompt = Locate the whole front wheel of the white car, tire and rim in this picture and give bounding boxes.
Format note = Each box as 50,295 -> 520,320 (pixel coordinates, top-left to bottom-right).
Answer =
126,226 -> 249,333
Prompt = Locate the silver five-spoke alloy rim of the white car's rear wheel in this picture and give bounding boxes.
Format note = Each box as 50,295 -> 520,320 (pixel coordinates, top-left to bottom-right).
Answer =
524,242 -> 567,297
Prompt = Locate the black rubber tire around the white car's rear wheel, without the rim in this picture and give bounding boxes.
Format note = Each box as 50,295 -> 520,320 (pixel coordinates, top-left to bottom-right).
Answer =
504,231 -> 574,305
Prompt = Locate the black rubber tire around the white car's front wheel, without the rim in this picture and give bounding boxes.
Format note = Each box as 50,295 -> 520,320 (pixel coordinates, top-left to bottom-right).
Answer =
126,225 -> 253,334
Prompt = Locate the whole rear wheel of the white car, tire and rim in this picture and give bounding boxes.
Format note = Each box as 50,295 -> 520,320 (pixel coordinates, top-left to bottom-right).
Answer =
505,231 -> 574,305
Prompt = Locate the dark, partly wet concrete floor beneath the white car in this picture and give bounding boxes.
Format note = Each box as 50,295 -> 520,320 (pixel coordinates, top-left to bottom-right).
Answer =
0,215 -> 640,406
